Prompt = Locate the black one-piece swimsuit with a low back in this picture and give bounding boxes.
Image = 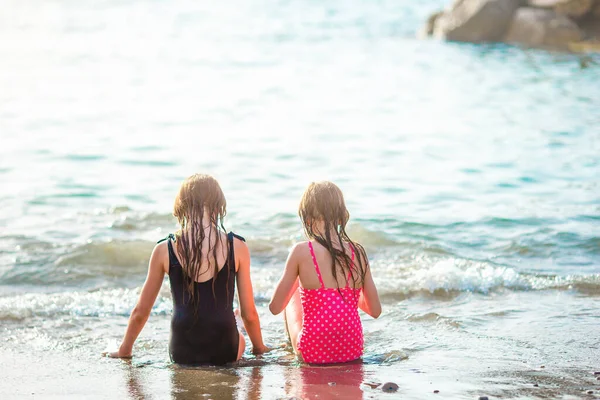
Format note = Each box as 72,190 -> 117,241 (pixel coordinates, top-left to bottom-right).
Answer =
166,232 -> 244,365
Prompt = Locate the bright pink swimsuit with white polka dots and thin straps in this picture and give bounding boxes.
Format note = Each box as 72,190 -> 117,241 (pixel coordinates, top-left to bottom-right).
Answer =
298,242 -> 364,364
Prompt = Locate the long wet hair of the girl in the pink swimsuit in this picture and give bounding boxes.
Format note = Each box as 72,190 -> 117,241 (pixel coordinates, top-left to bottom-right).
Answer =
298,181 -> 368,294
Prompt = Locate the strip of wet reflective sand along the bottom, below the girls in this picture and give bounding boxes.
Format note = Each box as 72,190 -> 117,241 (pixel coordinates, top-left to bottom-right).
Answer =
0,350 -> 600,400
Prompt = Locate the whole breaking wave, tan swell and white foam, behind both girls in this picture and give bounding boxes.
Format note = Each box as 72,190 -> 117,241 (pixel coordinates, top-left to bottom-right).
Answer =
0,220 -> 600,301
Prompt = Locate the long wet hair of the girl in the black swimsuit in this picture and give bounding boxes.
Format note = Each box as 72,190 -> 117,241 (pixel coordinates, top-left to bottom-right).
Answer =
173,174 -> 229,305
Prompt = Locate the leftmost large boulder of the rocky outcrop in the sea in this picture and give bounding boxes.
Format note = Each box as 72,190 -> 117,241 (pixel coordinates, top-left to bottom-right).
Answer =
433,0 -> 521,43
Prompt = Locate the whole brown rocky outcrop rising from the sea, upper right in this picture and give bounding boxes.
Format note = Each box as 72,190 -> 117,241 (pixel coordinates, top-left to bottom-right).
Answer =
422,0 -> 600,51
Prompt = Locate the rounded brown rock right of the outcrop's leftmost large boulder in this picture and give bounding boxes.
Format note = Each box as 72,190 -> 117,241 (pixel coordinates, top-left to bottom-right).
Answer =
504,7 -> 583,48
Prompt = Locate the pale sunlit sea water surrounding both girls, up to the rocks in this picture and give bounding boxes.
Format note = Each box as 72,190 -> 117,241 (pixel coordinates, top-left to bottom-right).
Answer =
0,0 -> 600,398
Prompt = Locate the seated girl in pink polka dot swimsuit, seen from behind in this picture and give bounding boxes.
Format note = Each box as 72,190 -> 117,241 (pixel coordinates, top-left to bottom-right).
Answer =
269,182 -> 381,364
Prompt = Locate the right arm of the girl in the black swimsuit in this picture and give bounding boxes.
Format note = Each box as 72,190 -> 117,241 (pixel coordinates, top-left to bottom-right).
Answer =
233,239 -> 269,354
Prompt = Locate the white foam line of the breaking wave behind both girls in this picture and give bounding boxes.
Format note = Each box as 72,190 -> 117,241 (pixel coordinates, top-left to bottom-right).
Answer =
0,268 -> 600,327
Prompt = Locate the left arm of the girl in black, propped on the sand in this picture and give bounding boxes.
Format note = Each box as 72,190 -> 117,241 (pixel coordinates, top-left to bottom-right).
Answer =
108,242 -> 169,358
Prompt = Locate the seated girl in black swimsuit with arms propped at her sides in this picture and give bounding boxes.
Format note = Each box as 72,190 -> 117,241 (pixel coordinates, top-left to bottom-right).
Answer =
108,174 -> 268,365
